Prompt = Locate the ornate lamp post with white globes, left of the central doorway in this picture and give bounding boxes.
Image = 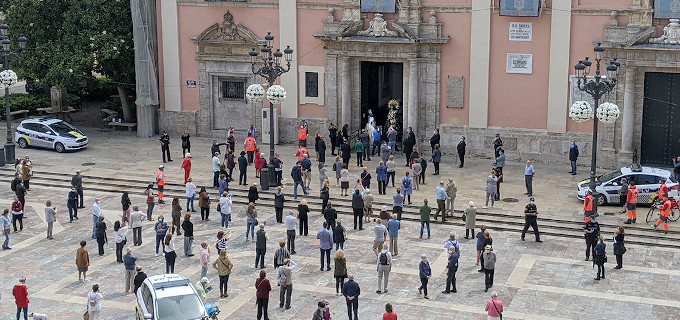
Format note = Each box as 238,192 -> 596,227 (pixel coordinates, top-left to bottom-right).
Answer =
246,32 -> 293,186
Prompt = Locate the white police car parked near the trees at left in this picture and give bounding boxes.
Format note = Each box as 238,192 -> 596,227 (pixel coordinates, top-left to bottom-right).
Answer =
14,117 -> 87,152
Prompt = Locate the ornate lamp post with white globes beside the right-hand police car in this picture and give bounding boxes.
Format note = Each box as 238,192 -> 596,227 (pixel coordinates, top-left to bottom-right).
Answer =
569,43 -> 621,215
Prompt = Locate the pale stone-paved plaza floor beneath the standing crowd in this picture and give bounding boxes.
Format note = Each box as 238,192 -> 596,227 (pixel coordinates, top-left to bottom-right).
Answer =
0,128 -> 680,320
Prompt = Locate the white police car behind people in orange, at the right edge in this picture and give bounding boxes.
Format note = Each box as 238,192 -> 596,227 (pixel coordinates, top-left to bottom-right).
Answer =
577,165 -> 678,206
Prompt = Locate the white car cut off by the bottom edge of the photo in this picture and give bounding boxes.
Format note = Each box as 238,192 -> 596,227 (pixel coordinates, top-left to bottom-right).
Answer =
135,274 -> 208,320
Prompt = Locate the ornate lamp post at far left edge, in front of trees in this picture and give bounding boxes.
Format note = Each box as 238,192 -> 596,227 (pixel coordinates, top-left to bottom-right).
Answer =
0,23 -> 28,165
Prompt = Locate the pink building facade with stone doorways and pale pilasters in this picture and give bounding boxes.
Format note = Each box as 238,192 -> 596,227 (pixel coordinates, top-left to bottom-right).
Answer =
157,0 -> 680,167
